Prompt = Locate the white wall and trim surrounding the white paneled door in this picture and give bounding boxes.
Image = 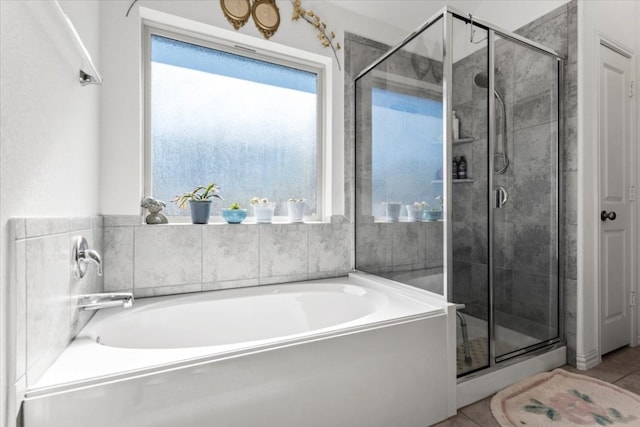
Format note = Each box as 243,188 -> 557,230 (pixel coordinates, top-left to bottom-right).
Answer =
576,0 -> 640,368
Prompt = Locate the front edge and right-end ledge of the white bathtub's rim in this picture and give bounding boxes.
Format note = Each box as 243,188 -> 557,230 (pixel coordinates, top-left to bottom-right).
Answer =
24,271 -> 455,400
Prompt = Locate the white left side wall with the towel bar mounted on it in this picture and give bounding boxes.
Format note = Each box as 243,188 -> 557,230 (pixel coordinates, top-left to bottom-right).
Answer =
0,0 -> 100,426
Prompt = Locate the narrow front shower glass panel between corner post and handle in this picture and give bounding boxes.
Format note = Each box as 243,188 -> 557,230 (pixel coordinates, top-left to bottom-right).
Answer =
449,18 -> 490,375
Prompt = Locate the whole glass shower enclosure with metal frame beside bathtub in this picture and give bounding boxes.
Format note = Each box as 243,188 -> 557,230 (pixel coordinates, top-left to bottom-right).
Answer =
355,8 -> 562,376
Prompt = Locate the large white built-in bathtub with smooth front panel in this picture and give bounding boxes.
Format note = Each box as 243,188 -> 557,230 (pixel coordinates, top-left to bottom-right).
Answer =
23,274 -> 456,427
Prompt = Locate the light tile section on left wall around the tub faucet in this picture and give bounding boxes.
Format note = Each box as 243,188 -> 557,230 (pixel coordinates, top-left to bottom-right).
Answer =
9,217 -> 103,387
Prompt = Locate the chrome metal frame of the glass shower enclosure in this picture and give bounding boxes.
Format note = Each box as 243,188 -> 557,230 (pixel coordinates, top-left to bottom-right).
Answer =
354,6 -> 565,382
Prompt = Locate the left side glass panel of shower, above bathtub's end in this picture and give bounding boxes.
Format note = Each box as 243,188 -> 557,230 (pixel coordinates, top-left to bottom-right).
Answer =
355,19 -> 444,295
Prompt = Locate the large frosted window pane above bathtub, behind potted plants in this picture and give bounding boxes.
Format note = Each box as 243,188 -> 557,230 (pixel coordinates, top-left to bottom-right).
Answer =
147,34 -> 320,216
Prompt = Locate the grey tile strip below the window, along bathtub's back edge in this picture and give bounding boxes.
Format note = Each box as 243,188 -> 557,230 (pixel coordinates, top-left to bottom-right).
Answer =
104,216 -> 353,297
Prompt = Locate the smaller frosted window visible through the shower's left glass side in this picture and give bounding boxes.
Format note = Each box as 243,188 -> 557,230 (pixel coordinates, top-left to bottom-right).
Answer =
371,87 -> 442,217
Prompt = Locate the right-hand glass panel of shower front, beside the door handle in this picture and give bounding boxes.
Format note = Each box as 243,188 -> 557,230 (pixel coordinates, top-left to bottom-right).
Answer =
492,37 -> 559,361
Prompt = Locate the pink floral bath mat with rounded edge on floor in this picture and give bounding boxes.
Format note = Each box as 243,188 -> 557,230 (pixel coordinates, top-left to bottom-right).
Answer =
491,369 -> 640,427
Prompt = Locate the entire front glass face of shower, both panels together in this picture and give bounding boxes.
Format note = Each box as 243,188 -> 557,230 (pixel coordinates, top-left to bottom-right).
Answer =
445,15 -> 560,375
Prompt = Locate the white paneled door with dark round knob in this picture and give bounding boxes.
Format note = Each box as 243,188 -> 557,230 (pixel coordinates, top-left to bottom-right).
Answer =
594,41 -> 632,354
